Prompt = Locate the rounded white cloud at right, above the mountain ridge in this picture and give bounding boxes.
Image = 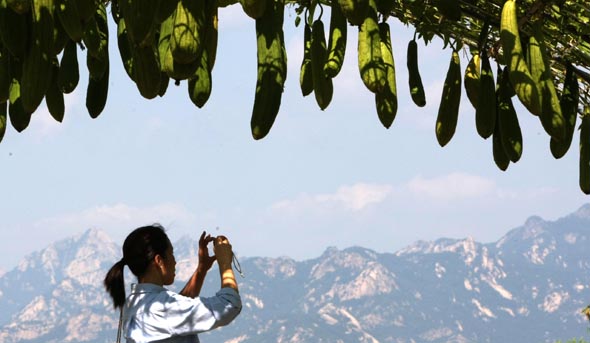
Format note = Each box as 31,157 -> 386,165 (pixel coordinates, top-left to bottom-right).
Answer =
407,173 -> 496,200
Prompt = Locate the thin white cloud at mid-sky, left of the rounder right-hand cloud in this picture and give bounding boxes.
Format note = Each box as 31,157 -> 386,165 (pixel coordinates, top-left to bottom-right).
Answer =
272,183 -> 392,212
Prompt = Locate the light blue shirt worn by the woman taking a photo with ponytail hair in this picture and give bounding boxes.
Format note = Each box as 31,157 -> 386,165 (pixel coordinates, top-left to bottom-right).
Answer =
122,283 -> 242,343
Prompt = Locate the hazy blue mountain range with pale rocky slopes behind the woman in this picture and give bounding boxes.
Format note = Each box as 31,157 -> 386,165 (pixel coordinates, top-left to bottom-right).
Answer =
0,204 -> 590,343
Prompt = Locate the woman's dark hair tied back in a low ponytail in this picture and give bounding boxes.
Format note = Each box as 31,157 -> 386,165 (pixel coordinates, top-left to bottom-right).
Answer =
104,224 -> 170,308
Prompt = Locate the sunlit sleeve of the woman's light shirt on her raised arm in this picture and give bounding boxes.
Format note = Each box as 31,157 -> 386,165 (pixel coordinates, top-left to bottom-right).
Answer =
165,288 -> 242,335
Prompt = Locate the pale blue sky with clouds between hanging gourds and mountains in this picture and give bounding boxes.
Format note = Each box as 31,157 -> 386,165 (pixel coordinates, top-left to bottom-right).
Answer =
0,5 -> 588,272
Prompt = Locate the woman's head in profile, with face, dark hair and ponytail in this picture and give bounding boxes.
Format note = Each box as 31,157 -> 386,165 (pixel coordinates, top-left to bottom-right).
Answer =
104,224 -> 175,308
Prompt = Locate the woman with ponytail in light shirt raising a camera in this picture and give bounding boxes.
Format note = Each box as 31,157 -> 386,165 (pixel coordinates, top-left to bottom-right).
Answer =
104,225 -> 242,343
